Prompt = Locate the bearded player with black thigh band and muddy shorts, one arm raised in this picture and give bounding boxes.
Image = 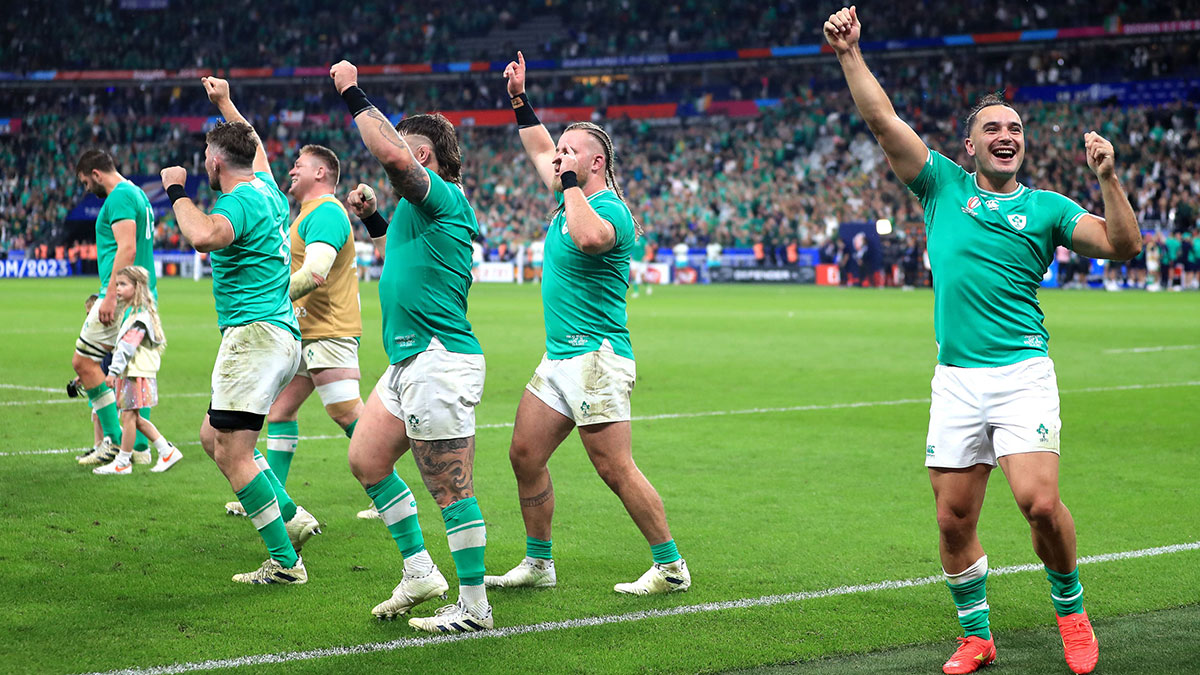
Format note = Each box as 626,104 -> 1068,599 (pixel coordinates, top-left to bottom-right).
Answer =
162,78 -> 308,584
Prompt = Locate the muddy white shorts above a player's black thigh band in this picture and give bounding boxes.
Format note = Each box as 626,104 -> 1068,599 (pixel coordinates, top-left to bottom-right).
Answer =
211,321 -> 300,414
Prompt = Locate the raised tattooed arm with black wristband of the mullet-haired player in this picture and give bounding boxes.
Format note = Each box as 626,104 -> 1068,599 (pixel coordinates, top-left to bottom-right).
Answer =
329,61 -> 430,204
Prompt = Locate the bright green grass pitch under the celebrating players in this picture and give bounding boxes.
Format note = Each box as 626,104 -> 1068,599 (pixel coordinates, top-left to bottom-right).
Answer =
0,279 -> 1200,673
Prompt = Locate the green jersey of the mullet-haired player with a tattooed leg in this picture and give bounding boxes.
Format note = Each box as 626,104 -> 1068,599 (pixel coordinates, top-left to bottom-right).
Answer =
379,168 -> 484,364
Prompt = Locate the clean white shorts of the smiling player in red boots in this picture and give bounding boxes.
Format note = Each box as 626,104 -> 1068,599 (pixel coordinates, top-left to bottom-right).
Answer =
925,357 -> 1062,468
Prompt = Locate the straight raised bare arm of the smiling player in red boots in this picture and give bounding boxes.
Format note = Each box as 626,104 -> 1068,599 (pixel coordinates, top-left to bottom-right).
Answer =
824,6 -> 929,185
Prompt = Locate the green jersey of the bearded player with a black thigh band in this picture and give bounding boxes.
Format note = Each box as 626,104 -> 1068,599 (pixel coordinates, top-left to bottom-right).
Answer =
209,172 -> 300,340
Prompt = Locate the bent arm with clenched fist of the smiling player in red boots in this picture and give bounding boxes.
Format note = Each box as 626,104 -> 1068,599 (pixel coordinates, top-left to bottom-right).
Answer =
1070,131 -> 1141,261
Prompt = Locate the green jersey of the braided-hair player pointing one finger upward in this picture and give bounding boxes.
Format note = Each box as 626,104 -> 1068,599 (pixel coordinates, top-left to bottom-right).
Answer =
541,189 -> 637,359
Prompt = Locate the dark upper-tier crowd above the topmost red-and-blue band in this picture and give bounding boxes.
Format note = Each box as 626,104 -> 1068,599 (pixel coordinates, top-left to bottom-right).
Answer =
0,0 -> 1200,71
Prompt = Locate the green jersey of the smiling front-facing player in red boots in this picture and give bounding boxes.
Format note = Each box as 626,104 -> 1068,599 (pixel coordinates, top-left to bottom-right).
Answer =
908,150 -> 1087,368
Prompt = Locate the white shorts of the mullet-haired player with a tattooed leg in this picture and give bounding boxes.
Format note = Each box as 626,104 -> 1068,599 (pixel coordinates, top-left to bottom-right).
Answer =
376,338 -> 486,441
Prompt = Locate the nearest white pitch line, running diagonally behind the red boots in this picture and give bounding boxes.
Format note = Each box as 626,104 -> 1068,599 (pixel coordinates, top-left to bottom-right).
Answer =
77,542 -> 1200,675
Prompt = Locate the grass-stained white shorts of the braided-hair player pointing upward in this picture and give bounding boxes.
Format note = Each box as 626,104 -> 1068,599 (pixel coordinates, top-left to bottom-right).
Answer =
526,340 -> 637,426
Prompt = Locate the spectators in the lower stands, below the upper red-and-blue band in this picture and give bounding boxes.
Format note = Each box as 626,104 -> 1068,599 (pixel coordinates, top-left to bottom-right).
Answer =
0,26 -> 1200,283
